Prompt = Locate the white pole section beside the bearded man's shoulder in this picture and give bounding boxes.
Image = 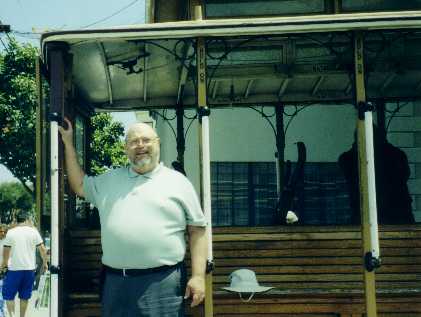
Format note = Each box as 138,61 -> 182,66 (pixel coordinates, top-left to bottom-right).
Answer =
201,115 -> 213,263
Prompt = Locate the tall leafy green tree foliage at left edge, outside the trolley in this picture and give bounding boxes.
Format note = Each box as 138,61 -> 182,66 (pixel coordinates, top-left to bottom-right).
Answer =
0,38 -> 38,196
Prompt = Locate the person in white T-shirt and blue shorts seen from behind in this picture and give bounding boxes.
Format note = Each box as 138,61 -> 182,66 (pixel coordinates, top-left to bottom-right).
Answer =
2,212 -> 48,317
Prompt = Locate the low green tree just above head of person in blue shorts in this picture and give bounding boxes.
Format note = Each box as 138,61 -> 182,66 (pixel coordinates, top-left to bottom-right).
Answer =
0,182 -> 34,223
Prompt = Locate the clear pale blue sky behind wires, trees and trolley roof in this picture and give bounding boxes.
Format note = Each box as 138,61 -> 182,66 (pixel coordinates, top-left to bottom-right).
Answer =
0,0 -> 145,183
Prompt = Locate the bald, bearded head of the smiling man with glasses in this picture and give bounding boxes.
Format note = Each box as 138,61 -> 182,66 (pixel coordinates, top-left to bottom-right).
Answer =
125,123 -> 159,174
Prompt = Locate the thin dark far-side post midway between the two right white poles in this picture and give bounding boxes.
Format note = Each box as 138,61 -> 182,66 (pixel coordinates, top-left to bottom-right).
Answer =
275,103 -> 285,199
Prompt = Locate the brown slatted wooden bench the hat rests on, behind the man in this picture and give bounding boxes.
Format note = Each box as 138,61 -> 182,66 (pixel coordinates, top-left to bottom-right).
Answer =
65,225 -> 421,317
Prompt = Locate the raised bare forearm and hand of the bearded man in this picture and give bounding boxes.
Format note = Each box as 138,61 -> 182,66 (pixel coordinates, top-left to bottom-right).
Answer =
58,118 -> 85,197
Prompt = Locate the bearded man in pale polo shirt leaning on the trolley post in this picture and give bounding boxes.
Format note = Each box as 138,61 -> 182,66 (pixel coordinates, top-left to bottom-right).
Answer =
59,119 -> 207,317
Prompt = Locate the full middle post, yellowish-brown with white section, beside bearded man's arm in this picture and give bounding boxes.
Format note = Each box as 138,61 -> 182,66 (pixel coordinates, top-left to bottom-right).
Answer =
196,34 -> 213,317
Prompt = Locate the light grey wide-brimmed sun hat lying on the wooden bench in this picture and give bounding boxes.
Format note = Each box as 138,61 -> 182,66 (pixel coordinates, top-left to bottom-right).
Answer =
222,269 -> 274,293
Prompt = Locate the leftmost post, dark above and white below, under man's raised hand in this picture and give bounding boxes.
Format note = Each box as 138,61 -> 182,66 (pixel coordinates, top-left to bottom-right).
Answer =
49,44 -> 65,317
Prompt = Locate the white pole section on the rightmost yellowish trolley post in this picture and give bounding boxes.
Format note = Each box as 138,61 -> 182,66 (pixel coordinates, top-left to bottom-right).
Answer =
364,111 -> 380,260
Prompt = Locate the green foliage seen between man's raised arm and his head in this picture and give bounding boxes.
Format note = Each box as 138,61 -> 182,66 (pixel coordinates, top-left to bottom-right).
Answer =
91,113 -> 128,175
